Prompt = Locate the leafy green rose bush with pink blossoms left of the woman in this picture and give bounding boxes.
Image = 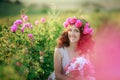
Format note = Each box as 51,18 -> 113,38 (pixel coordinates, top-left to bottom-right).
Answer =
0,14 -> 62,80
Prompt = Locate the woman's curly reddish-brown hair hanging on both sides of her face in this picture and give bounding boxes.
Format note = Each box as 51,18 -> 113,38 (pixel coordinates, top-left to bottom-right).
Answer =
57,19 -> 94,54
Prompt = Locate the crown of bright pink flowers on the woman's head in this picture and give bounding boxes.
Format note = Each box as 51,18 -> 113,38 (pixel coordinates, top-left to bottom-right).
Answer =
63,17 -> 94,34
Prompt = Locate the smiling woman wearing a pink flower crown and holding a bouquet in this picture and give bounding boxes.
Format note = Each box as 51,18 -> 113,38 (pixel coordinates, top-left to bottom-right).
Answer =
48,17 -> 95,80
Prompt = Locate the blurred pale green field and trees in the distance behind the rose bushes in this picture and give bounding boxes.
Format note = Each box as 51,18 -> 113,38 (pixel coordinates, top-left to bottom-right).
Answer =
0,0 -> 120,26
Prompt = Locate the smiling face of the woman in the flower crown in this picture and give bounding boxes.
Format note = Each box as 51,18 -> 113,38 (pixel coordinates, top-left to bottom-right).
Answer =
68,25 -> 80,43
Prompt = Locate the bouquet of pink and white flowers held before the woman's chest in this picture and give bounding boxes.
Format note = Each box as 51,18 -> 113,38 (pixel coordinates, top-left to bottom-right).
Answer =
64,57 -> 95,80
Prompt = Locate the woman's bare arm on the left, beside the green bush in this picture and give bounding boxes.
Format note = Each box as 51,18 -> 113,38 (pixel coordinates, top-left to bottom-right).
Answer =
54,49 -> 70,80
